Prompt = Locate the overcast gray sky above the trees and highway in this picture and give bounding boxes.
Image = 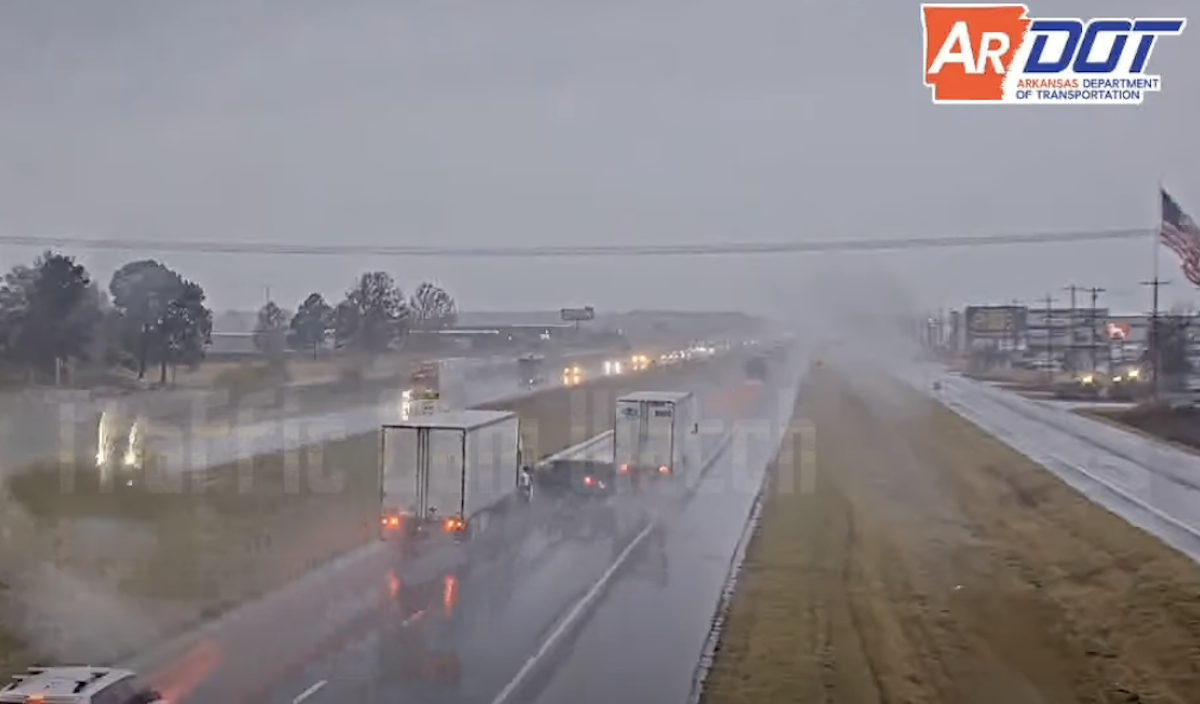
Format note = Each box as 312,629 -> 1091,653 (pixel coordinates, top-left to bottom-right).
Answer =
0,0 -> 1200,311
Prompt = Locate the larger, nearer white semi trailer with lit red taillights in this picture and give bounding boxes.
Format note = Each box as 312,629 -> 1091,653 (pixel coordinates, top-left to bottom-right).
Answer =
380,410 -> 530,538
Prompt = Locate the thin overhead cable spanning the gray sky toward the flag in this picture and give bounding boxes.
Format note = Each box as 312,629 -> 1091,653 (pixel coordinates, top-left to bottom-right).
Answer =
0,228 -> 1156,258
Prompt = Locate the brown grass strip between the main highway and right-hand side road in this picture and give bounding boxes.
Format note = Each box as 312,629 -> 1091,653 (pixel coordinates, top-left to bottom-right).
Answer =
703,366 -> 1200,704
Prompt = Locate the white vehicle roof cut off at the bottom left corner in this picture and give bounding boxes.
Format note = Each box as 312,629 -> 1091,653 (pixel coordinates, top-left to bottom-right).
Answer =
0,666 -> 167,704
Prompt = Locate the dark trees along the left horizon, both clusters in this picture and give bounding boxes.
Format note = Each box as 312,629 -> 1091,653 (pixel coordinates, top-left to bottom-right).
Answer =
0,251 -> 456,384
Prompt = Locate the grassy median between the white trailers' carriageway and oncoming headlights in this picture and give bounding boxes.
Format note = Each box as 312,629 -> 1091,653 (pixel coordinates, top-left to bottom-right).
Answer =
0,361 -> 744,662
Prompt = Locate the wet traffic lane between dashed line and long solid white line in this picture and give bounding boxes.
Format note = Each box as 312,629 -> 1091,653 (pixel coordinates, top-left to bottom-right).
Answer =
252,426 -> 720,704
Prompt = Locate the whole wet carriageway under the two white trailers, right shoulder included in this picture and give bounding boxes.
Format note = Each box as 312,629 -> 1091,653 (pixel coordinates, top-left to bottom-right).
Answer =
133,359 -> 794,704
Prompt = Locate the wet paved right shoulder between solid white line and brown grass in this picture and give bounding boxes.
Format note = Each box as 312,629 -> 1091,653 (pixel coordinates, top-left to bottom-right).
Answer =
523,395 -> 791,704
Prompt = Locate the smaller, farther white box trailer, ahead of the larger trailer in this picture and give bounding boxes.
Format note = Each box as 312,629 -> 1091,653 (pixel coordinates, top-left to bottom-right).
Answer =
612,391 -> 701,476
